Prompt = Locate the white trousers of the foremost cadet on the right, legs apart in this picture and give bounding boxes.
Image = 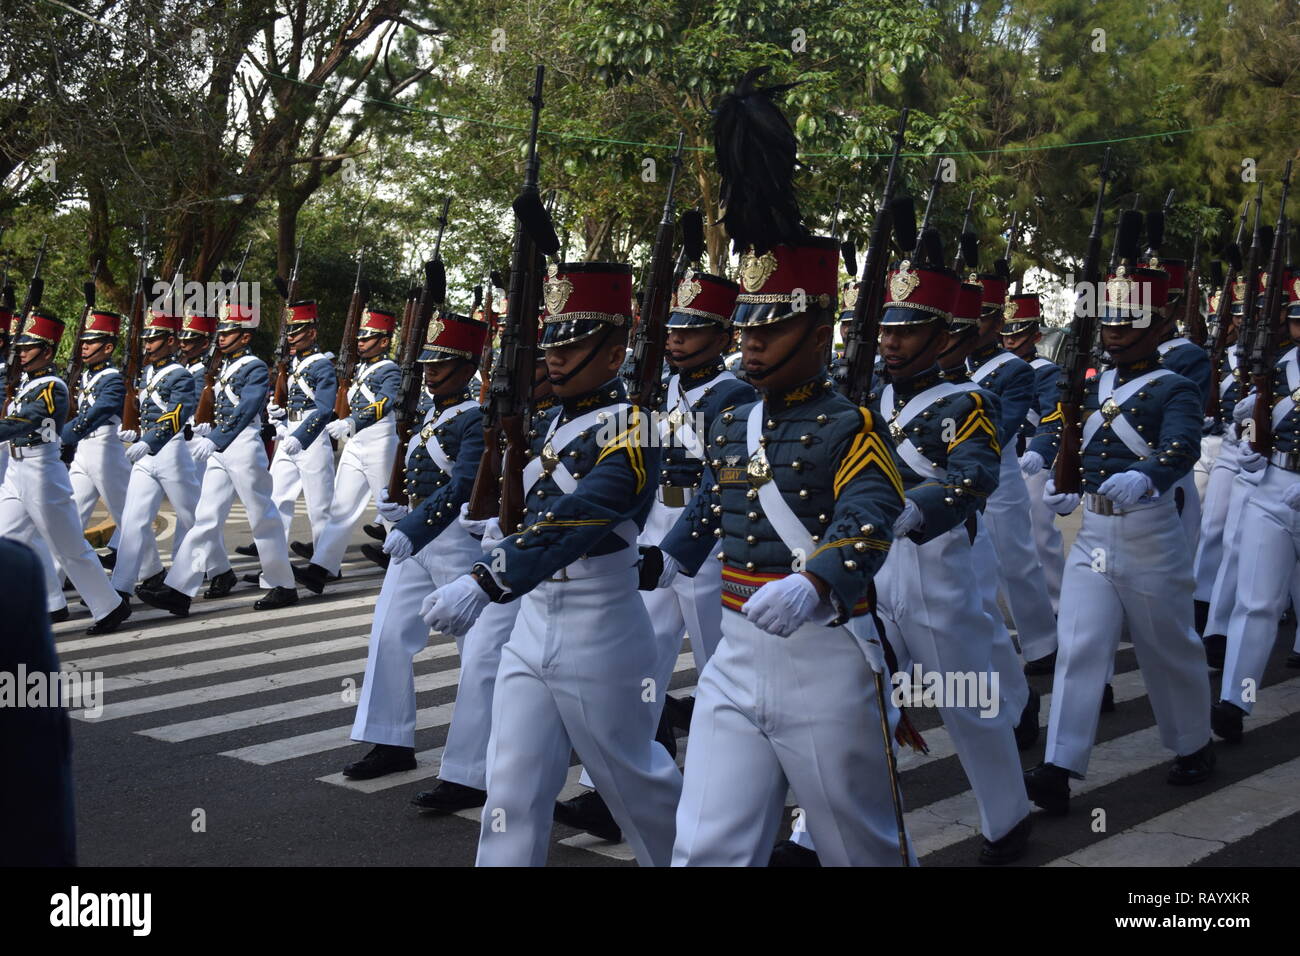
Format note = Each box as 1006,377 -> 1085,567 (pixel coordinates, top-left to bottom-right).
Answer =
1045,496 -> 1210,778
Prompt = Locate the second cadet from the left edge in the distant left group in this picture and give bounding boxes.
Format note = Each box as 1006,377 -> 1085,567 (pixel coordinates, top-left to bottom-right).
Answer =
60,308 -> 133,572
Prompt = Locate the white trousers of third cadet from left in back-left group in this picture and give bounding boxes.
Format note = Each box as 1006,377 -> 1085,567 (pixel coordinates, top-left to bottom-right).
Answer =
113,434 -> 199,593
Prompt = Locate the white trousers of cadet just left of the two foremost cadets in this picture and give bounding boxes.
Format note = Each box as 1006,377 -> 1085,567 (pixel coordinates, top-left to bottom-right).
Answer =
352,522 -> 480,747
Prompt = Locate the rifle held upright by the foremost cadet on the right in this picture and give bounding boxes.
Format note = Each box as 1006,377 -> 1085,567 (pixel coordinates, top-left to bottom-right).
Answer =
1054,148 -> 1110,494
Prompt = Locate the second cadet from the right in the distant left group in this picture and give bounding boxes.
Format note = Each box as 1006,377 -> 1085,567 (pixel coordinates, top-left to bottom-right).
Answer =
267,299 -> 338,551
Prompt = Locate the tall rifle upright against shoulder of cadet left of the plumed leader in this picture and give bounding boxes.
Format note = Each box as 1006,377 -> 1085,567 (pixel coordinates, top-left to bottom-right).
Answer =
469,66 -> 560,533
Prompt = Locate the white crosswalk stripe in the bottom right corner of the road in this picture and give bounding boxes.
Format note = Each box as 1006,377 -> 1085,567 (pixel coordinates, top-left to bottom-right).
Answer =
1047,757 -> 1300,866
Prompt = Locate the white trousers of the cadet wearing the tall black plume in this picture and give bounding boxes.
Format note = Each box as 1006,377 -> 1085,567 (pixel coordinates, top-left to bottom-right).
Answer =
672,610 -> 902,866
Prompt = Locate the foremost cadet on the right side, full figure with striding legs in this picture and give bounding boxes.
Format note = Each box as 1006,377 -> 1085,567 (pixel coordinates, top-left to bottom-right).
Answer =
1024,267 -> 1216,814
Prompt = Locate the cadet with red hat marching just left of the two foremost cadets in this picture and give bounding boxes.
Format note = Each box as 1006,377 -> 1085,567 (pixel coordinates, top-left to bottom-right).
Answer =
343,312 -> 488,780
